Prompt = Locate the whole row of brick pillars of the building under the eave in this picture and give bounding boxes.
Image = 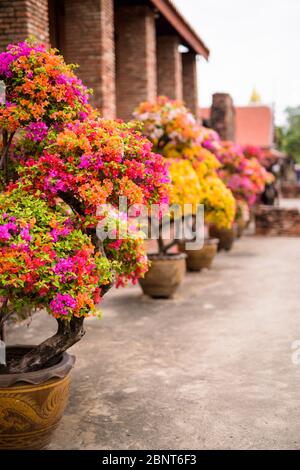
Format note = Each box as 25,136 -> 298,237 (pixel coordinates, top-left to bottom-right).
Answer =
0,0 -> 202,119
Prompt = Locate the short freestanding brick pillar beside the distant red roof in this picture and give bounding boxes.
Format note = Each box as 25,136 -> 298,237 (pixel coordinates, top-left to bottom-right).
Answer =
211,93 -> 235,140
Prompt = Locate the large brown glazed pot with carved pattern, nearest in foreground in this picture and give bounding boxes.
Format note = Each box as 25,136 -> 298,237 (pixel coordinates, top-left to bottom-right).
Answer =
0,346 -> 75,450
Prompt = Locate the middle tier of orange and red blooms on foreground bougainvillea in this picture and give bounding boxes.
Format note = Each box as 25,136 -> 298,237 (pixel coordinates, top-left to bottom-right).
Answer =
15,119 -> 168,227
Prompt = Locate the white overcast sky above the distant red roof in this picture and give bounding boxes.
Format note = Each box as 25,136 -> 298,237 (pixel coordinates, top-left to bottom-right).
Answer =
174,0 -> 300,124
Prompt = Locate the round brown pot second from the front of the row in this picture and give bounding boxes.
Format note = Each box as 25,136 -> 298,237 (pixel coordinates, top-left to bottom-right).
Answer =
139,253 -> 186,299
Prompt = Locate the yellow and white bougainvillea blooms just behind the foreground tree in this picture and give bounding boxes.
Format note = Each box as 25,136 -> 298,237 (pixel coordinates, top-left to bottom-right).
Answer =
134,96 -> 235,253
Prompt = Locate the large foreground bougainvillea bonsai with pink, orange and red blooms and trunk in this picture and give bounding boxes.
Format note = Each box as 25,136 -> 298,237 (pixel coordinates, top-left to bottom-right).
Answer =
0,42 -> 168,373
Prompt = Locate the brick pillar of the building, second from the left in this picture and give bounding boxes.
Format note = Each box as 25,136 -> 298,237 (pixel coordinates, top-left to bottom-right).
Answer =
62,0 -> 116,118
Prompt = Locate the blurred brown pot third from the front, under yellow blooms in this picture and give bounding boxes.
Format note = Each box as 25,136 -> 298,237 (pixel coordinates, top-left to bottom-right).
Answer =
178,238 -> 219,271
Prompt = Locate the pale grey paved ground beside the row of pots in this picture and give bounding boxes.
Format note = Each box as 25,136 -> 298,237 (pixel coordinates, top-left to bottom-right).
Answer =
5,237 -> 300,449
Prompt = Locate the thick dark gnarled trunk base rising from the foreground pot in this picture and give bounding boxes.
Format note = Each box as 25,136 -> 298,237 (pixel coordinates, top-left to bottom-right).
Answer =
7,317 -> 85,374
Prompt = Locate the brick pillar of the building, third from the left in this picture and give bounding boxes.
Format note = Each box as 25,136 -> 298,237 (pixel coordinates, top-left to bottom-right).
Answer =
115,5 -> 157,120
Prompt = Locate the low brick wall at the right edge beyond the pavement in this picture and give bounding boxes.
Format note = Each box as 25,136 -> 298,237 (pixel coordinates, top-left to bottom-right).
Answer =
255,206 -> 300,237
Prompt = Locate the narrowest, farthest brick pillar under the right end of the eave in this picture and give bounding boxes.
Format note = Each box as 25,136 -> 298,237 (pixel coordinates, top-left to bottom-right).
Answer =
182,51 -> 198,115
